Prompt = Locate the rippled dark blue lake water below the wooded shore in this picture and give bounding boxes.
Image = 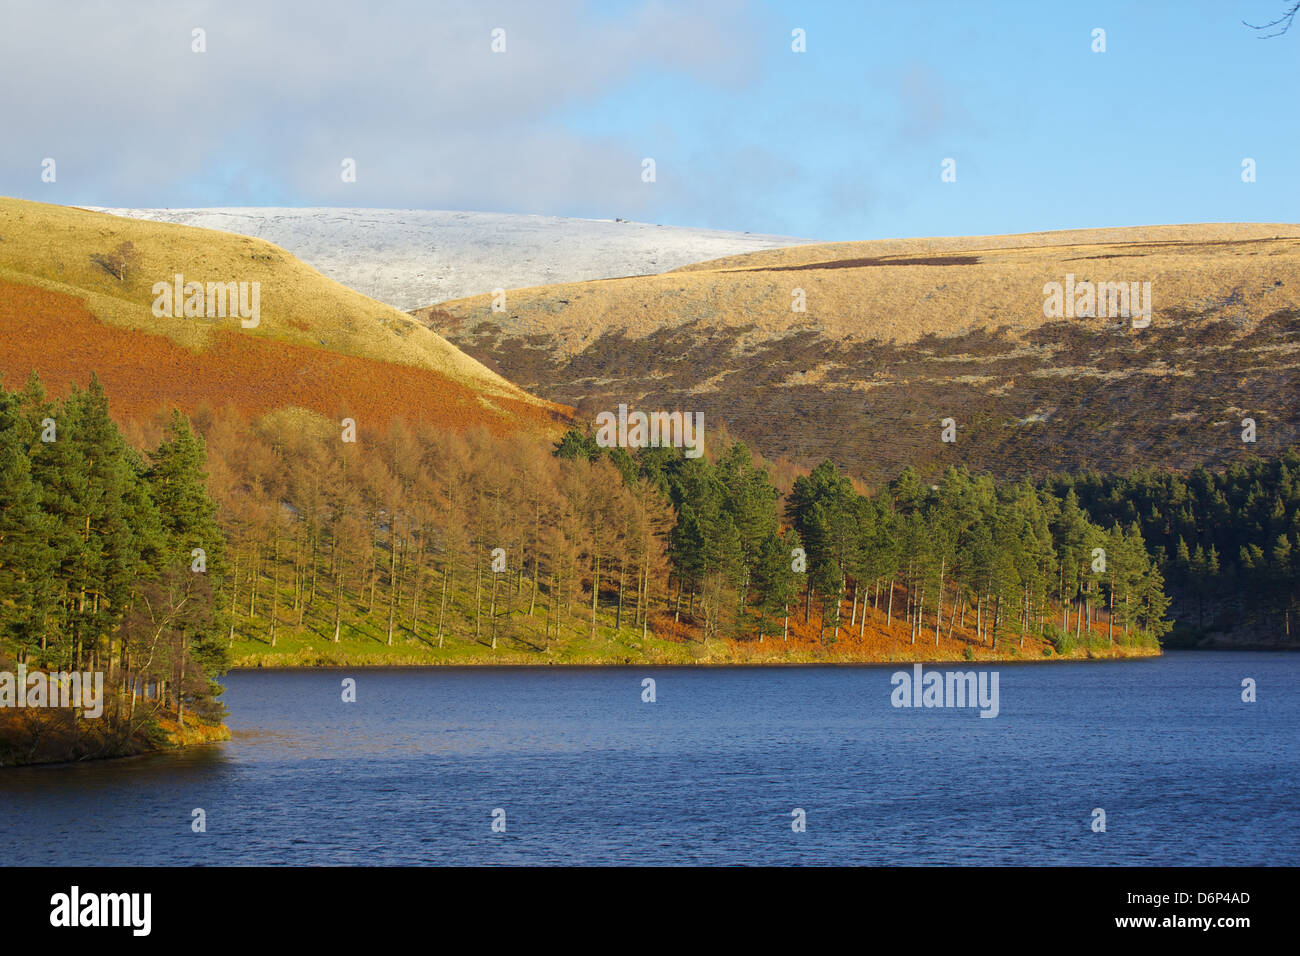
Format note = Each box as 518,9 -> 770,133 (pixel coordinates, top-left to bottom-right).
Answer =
0,652 -> 1300,865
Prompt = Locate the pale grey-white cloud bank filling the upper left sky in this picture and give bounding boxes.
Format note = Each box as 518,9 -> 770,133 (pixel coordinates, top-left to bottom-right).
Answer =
0,0 -> 758,215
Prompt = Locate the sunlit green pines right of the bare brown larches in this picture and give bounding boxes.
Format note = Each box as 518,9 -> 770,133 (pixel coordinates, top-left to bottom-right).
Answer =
556,431 -> 1170,648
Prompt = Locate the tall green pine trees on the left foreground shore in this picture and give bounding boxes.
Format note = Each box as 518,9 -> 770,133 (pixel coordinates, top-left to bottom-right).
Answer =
0,375 -> 225,723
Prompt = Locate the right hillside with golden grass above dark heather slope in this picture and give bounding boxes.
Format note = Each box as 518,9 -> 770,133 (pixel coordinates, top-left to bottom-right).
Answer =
416,224 -> 1300,480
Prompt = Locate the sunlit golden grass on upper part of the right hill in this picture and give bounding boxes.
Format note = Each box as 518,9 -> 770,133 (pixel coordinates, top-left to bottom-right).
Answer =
417,224 -> 1300,354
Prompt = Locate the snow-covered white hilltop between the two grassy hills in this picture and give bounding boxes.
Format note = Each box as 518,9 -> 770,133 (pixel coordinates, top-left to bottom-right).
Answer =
100,207 -> 809,311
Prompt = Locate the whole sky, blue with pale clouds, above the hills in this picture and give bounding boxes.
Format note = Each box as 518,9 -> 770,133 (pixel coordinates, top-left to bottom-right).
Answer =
0,0 -> 1300,239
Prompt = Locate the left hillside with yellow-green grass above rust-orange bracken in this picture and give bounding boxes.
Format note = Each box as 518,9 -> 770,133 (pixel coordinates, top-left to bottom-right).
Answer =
0,199 -> 566,433
